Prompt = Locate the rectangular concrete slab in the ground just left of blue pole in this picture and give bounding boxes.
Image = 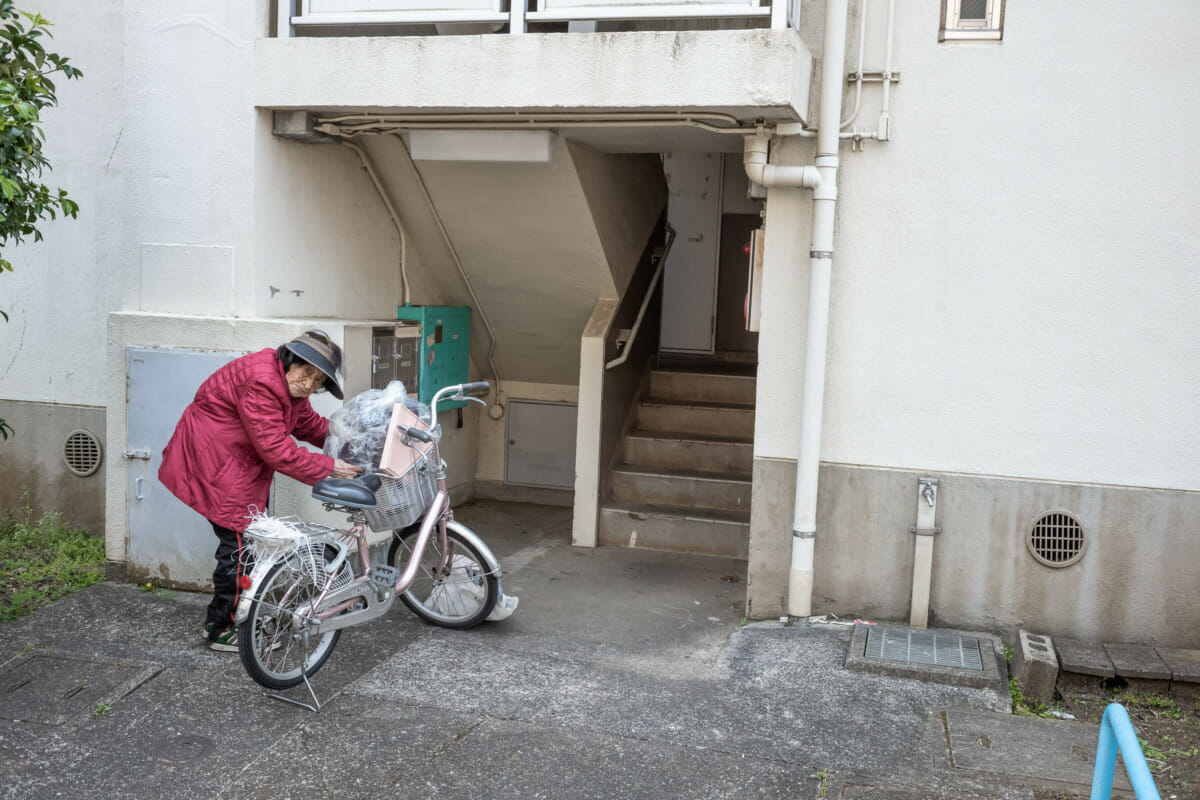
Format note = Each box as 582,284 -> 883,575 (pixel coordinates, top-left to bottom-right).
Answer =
946,710 -> 1130,789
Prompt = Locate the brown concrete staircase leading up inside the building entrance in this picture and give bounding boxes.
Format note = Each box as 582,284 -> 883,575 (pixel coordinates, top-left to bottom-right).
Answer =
599,367 -> 755,559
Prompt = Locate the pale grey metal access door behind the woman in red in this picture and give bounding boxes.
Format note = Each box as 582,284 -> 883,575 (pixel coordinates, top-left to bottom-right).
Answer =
125,347 -> 244,588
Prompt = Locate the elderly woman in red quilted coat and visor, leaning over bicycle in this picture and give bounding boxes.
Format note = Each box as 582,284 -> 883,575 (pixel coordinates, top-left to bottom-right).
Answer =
158,331 -> 361,652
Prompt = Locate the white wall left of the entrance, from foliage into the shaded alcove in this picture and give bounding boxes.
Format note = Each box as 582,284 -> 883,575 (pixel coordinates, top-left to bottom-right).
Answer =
0,0 -> 412,405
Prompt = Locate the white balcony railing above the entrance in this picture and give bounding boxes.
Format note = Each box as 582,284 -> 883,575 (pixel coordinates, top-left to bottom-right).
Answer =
276,0 -> 800,37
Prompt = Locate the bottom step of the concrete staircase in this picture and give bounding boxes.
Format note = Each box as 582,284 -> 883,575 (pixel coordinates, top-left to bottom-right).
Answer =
598,503 -> 750,560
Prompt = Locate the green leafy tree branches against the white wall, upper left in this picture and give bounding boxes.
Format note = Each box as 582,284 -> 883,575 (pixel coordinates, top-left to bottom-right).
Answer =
0,0 -> 83,293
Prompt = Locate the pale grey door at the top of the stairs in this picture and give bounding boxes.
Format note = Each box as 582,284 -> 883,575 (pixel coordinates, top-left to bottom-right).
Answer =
659,152 -> 722,353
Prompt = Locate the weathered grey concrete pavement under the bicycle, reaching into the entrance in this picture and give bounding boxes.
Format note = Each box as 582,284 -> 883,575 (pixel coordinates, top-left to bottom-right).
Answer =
0,503 -> 1123,800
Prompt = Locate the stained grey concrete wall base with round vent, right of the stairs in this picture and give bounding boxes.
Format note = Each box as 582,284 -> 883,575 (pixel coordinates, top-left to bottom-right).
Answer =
749,459 -> 1200,648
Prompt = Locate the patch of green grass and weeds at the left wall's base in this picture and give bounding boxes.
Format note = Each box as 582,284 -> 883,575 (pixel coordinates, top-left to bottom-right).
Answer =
0,510 -> 104,621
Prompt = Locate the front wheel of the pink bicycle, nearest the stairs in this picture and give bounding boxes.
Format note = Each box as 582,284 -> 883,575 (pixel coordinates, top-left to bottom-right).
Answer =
388,522 -> 500,628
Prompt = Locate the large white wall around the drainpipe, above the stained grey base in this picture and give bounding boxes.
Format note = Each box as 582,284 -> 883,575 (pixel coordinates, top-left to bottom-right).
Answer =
756,0 -> 1200,489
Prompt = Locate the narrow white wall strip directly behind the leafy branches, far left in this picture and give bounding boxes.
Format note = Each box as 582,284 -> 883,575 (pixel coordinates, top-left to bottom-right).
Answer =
0,0 -> 128,407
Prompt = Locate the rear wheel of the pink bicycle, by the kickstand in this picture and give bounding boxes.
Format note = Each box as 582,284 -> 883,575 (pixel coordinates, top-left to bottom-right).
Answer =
238,547 -> 349,690
